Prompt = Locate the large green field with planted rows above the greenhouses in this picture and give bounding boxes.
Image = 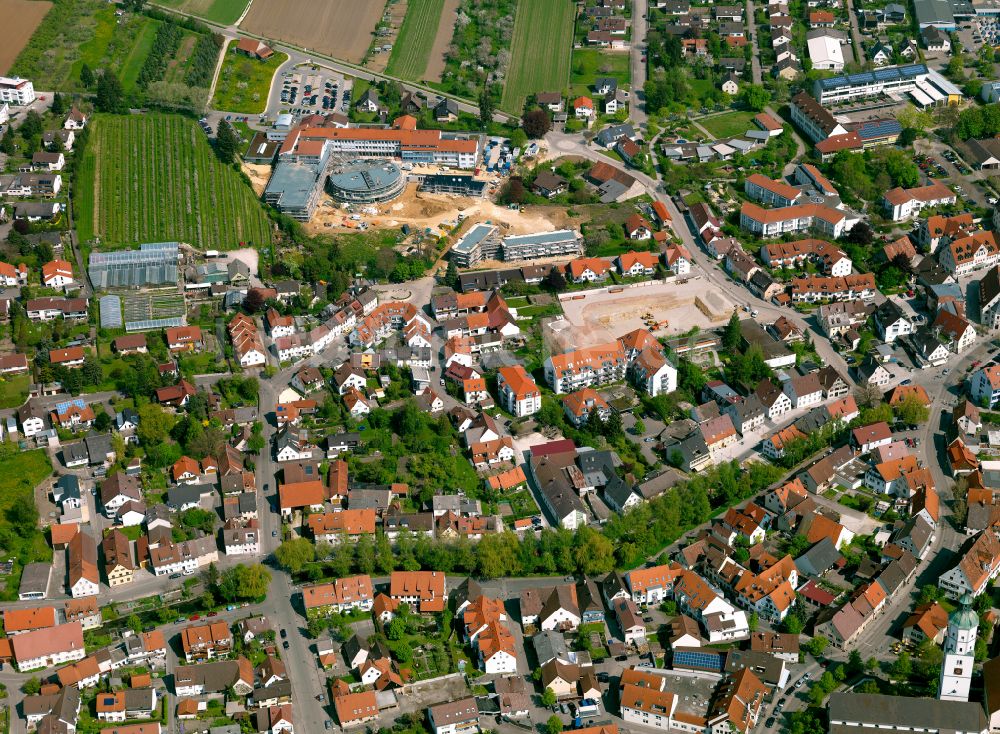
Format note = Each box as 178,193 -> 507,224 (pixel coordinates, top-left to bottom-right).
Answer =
74,114 -> 271,249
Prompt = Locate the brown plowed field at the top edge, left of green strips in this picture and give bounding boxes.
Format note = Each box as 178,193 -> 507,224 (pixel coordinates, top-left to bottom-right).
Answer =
240,0 -> 385,64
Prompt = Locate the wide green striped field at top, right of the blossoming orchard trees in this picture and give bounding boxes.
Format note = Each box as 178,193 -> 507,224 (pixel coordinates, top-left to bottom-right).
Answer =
500,0 -> 576,114
